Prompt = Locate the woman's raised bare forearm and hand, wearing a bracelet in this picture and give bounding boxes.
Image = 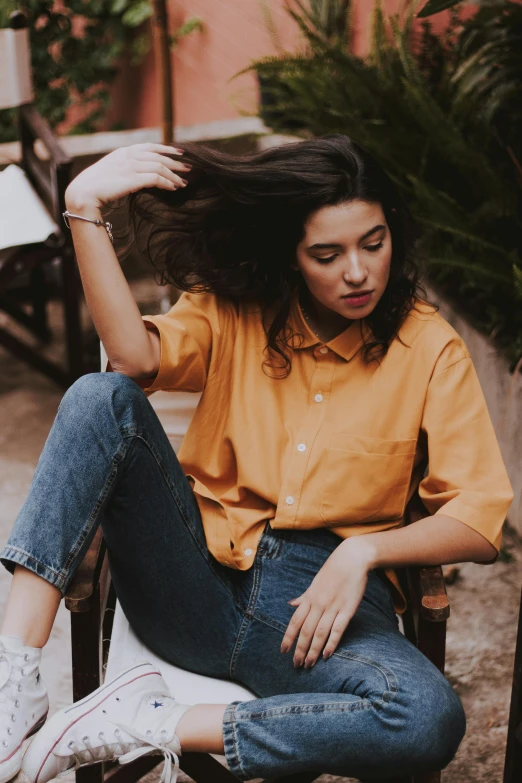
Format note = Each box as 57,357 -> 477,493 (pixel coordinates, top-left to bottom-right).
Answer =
65,144 -> 189,378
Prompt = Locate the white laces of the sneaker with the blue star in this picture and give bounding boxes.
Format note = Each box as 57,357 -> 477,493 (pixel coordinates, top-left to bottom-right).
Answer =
57,724 -> 179,783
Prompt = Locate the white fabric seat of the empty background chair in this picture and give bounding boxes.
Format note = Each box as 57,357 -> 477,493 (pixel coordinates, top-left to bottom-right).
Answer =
0,165 -> 60,250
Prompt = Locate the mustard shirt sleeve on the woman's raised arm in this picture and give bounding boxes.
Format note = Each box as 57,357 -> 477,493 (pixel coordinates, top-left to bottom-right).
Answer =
140,293 -> 213,394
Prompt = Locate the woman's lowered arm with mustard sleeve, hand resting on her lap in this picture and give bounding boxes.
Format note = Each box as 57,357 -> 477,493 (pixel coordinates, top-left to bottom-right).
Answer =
281,348 -> 513,667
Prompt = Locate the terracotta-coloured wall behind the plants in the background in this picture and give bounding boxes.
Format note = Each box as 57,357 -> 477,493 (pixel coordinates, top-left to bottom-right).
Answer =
63,0 -> 458,133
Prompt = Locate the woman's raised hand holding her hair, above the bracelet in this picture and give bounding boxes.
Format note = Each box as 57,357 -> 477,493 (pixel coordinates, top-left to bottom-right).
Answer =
65,143 -> 191,209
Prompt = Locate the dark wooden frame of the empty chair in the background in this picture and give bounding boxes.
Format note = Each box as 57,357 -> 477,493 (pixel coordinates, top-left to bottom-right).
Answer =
0,11 -> 84,387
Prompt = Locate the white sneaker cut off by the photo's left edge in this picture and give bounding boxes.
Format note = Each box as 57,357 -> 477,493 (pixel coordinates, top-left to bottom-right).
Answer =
0,636 -> 49,783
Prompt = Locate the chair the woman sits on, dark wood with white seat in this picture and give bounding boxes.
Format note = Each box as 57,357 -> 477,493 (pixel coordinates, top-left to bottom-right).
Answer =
65,370 -> 449,783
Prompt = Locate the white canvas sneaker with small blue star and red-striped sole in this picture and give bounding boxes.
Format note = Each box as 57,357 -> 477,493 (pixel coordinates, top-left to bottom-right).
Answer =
22,663 -> 190,783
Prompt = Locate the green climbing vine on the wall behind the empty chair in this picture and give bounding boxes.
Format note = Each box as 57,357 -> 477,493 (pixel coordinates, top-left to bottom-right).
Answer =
0,0 -> 201,142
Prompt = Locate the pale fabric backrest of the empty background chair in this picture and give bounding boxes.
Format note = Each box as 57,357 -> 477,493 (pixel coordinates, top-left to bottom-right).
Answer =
0,28 -> 33,109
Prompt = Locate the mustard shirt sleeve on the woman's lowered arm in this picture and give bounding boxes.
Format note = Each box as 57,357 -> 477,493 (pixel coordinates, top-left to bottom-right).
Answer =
419,344 -> 513,552
